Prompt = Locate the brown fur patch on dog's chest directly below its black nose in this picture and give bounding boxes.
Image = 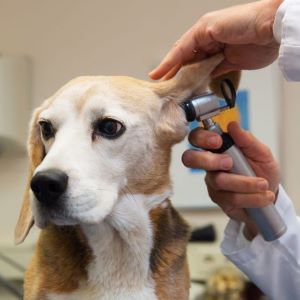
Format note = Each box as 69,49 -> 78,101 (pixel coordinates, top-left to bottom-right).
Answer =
25,226 -> 92,300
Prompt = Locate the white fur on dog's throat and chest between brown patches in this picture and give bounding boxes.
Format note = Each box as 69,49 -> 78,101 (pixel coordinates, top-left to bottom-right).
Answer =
48,191 -> 170,300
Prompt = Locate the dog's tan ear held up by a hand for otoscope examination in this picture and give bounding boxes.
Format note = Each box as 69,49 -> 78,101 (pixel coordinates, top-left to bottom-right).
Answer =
154,54 -> 240,143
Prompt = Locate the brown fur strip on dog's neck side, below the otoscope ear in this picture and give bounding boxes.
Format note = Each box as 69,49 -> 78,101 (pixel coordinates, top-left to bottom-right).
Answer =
150,200 -> 190,300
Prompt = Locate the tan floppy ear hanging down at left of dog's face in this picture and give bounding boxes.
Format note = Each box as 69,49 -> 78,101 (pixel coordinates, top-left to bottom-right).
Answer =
15,108 -> 45,245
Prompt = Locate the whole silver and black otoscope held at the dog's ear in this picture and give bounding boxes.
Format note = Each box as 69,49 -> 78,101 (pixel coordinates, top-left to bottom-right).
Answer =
181,79 -> 287,241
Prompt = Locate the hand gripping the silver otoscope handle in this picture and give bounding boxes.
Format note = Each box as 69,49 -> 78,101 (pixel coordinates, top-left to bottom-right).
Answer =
182,122 -> 280,239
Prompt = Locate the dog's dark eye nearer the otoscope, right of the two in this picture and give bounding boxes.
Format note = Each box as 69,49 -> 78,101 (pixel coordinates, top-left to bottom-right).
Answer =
94,118 -> 125,139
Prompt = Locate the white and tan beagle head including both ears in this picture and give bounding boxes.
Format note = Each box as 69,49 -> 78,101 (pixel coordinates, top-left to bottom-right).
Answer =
15,55 -> 241,243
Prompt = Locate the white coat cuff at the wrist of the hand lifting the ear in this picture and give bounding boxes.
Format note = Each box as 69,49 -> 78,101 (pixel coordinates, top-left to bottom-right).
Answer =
273,0 -> 300,81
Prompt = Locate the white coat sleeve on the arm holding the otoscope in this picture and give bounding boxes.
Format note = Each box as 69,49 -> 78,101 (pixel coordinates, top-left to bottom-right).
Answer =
221,187 -> 300,300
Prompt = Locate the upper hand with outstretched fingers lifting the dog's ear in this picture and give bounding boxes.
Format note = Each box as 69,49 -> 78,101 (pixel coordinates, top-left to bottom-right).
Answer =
149,0 -> 282,79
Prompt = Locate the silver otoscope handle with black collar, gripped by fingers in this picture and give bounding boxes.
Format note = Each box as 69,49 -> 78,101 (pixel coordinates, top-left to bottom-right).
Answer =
214,129 -> 287,241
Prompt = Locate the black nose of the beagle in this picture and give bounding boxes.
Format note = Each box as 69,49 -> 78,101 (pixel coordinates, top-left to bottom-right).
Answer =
30,169 -> 68,205
